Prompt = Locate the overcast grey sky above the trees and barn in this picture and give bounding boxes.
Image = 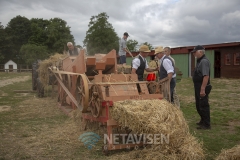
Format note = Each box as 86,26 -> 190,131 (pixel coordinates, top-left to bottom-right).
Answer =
0,0 -> 240,47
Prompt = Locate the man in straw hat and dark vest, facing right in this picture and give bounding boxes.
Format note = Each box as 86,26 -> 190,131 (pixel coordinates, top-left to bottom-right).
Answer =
132,45 -> 158,81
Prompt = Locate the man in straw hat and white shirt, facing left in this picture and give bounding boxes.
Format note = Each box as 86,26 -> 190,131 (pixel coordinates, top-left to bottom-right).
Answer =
155,46 -> 176,103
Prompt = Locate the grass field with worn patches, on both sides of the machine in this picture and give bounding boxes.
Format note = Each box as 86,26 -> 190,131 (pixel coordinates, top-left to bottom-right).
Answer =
0,73 -> 240,160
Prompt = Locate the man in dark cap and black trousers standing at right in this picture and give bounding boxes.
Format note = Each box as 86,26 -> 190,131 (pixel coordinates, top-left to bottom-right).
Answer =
191,45 -> 212,129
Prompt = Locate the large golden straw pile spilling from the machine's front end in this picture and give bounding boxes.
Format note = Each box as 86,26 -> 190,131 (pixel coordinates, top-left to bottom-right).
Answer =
111,100 -> 204,160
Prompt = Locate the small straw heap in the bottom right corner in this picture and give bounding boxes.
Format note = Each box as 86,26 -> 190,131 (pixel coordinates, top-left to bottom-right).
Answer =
216,145 -> 240,160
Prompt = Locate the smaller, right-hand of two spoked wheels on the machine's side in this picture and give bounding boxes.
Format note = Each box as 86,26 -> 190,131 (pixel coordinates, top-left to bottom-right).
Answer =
89,85 -> 103,117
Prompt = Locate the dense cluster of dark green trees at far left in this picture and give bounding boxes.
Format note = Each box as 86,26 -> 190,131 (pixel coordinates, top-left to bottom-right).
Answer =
0,15 -> 74,64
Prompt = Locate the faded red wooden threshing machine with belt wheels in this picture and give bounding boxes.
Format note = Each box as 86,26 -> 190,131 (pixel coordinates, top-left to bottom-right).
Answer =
50,50 -> 170,150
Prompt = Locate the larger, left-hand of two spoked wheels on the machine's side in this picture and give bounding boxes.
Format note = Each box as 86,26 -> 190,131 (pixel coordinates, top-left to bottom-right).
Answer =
75,75 -> 89,113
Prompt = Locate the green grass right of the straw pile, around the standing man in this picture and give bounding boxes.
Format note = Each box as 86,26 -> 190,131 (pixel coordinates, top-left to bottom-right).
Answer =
177,79 -> 240,159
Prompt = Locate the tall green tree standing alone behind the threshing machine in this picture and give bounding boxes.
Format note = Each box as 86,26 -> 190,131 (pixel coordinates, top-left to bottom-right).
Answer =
83,12 -> 119,55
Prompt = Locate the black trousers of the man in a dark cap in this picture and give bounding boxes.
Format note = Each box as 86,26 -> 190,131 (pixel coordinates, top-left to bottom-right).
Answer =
194,84 -> 212,127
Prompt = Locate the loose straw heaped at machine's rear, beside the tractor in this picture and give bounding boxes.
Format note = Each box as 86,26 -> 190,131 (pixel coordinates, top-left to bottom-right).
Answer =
38,53 -> 67,86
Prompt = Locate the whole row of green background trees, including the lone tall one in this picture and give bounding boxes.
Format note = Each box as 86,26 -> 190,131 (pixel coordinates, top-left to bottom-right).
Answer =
0,12 -> 153,64
